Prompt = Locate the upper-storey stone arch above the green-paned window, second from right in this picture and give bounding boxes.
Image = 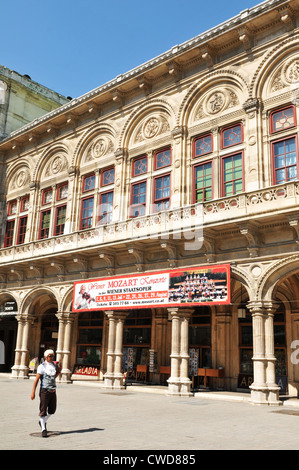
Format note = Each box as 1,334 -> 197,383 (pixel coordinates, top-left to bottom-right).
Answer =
177,67 -> 249,126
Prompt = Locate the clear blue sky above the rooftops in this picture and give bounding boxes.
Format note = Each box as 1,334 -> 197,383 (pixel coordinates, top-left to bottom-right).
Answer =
0,0 -> 261,98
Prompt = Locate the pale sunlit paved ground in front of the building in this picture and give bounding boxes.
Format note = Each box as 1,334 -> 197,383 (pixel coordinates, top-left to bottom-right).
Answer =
0,374 -> 299,455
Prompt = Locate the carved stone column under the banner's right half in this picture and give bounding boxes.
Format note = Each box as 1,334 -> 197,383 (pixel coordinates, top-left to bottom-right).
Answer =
168,308 -> 193,396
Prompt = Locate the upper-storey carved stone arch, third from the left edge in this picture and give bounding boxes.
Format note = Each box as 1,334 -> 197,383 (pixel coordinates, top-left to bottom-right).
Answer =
70,122 -> 116,168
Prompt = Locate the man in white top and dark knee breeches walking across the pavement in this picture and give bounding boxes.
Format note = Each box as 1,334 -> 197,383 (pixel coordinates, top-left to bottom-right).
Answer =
31,349 -> 60,437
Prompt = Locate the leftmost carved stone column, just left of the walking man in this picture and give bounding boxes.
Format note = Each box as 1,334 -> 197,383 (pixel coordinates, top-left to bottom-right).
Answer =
12,314 -> 34,379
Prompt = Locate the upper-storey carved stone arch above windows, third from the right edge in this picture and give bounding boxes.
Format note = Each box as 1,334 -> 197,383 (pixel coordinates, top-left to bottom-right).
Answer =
118,99 -> 175,148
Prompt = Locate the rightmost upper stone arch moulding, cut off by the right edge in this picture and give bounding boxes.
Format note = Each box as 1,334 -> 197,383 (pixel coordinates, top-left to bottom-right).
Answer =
250,34 -> 299,102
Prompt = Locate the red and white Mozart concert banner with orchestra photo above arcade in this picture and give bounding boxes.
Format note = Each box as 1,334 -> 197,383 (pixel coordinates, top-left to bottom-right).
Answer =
73,265 -> 230,312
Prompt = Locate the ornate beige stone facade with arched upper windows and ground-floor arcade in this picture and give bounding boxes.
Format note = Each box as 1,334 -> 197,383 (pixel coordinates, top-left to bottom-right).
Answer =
0,0 -> 299,404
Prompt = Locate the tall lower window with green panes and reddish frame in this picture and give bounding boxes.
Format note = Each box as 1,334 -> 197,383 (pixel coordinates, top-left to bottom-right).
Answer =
222,153 -> 243,196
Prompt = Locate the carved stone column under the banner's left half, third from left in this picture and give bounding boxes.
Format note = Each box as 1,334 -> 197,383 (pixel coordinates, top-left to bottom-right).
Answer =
104,311 -> 128,389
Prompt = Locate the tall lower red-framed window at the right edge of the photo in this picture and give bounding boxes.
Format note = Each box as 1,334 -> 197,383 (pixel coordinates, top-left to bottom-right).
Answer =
272,137 -> 298,184
